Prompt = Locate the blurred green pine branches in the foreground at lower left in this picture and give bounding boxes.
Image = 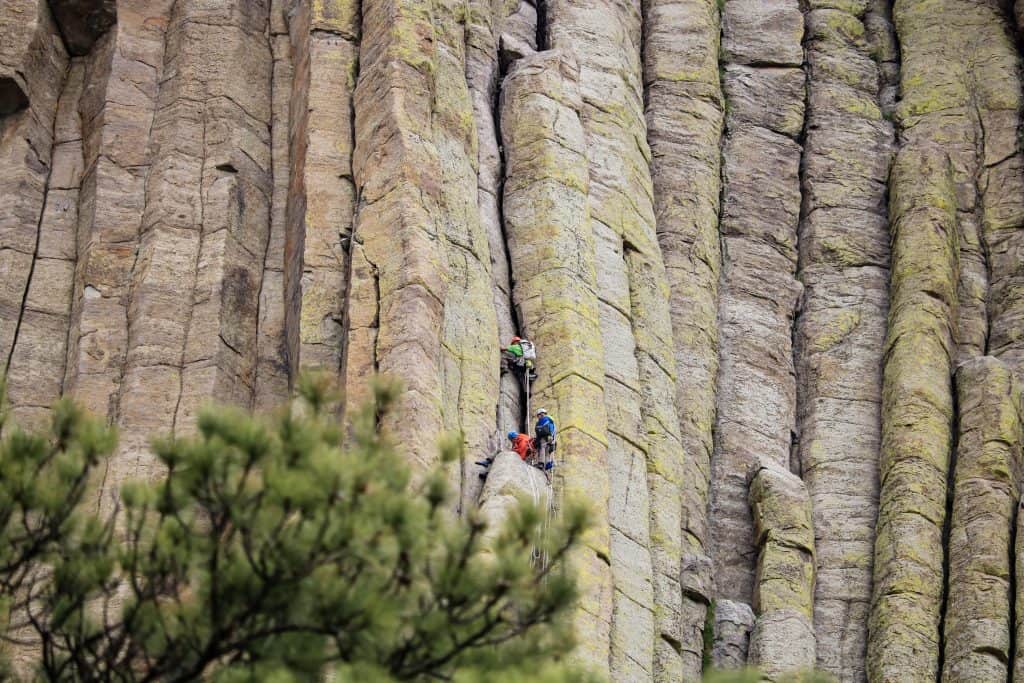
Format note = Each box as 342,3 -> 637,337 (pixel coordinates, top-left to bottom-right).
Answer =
0,380 -> 586,682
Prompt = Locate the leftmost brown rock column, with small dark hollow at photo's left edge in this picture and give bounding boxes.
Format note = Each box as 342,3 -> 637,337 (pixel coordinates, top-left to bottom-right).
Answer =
0,0 -> 68,387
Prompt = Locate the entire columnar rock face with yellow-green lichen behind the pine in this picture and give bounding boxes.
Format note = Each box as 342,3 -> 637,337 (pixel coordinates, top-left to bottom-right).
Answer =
9,0 -> 1024,682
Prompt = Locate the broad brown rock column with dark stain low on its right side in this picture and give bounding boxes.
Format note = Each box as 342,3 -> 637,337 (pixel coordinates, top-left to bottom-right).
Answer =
100,0 -> 271,499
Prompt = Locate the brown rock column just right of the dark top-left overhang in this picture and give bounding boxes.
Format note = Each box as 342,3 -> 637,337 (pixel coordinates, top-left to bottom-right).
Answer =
65,0 -> 172,448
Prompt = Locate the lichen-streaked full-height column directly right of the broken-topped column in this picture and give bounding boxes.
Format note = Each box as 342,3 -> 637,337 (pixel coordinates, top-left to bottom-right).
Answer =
546,0 -> 683,680
